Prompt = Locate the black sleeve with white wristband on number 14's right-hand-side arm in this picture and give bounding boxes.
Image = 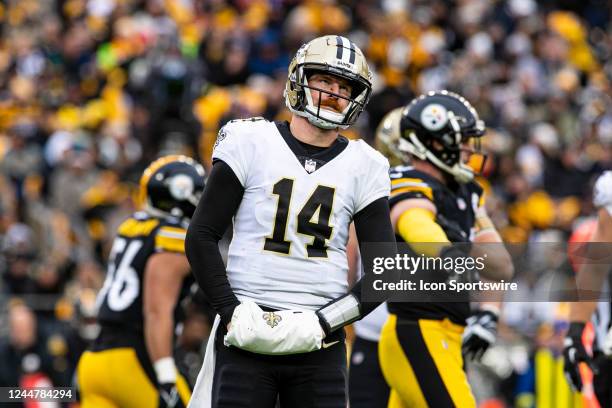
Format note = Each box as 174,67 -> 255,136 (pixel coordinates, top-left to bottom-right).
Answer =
317,197 -> 397,334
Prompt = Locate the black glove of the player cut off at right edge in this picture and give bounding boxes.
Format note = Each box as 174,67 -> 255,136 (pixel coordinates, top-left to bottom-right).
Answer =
563,322 -> 597,392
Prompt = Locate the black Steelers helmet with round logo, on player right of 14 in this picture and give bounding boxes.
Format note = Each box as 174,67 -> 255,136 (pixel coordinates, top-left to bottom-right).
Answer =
399,91 -> 485,183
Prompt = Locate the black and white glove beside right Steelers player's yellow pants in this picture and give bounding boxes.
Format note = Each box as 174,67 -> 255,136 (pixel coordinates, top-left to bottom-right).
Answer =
461,310 -> 498,361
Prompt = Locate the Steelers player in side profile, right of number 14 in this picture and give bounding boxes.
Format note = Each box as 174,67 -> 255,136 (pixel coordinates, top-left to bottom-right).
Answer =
379,91 -> 513,408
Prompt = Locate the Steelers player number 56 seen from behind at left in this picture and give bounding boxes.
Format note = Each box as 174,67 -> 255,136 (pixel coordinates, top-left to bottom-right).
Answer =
77,155 -> 205,408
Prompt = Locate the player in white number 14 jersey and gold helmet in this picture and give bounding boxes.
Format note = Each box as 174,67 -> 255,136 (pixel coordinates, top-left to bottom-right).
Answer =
186,35 -> 395,408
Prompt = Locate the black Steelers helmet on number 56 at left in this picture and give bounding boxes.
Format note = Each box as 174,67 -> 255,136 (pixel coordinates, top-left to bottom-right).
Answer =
139,155 -> 206,220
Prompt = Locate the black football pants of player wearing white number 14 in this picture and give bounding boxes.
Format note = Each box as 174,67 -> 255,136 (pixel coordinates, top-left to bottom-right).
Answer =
212,327 -> 347,408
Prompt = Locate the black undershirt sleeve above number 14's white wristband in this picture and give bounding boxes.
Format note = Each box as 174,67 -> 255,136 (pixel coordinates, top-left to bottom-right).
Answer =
351,197 -> 397,317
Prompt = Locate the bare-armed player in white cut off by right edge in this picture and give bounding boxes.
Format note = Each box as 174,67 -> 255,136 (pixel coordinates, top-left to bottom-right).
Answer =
563,171 -> 612,407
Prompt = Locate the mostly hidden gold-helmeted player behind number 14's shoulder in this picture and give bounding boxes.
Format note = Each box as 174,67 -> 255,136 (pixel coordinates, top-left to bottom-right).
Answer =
349,107 -> 406,408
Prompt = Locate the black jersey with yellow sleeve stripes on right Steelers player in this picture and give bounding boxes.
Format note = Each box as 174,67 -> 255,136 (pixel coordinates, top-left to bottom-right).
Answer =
389,166 -> 484,325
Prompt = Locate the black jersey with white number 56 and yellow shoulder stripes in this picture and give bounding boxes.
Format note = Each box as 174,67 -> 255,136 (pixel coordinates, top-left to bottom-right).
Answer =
97,212 -> 193,335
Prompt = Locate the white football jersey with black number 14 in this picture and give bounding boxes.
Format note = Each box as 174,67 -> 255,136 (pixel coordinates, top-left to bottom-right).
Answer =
213,119 -> 390,310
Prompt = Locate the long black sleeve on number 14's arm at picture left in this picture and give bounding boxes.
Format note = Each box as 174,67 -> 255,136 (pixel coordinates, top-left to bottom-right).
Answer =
185,160 -> 244,325
